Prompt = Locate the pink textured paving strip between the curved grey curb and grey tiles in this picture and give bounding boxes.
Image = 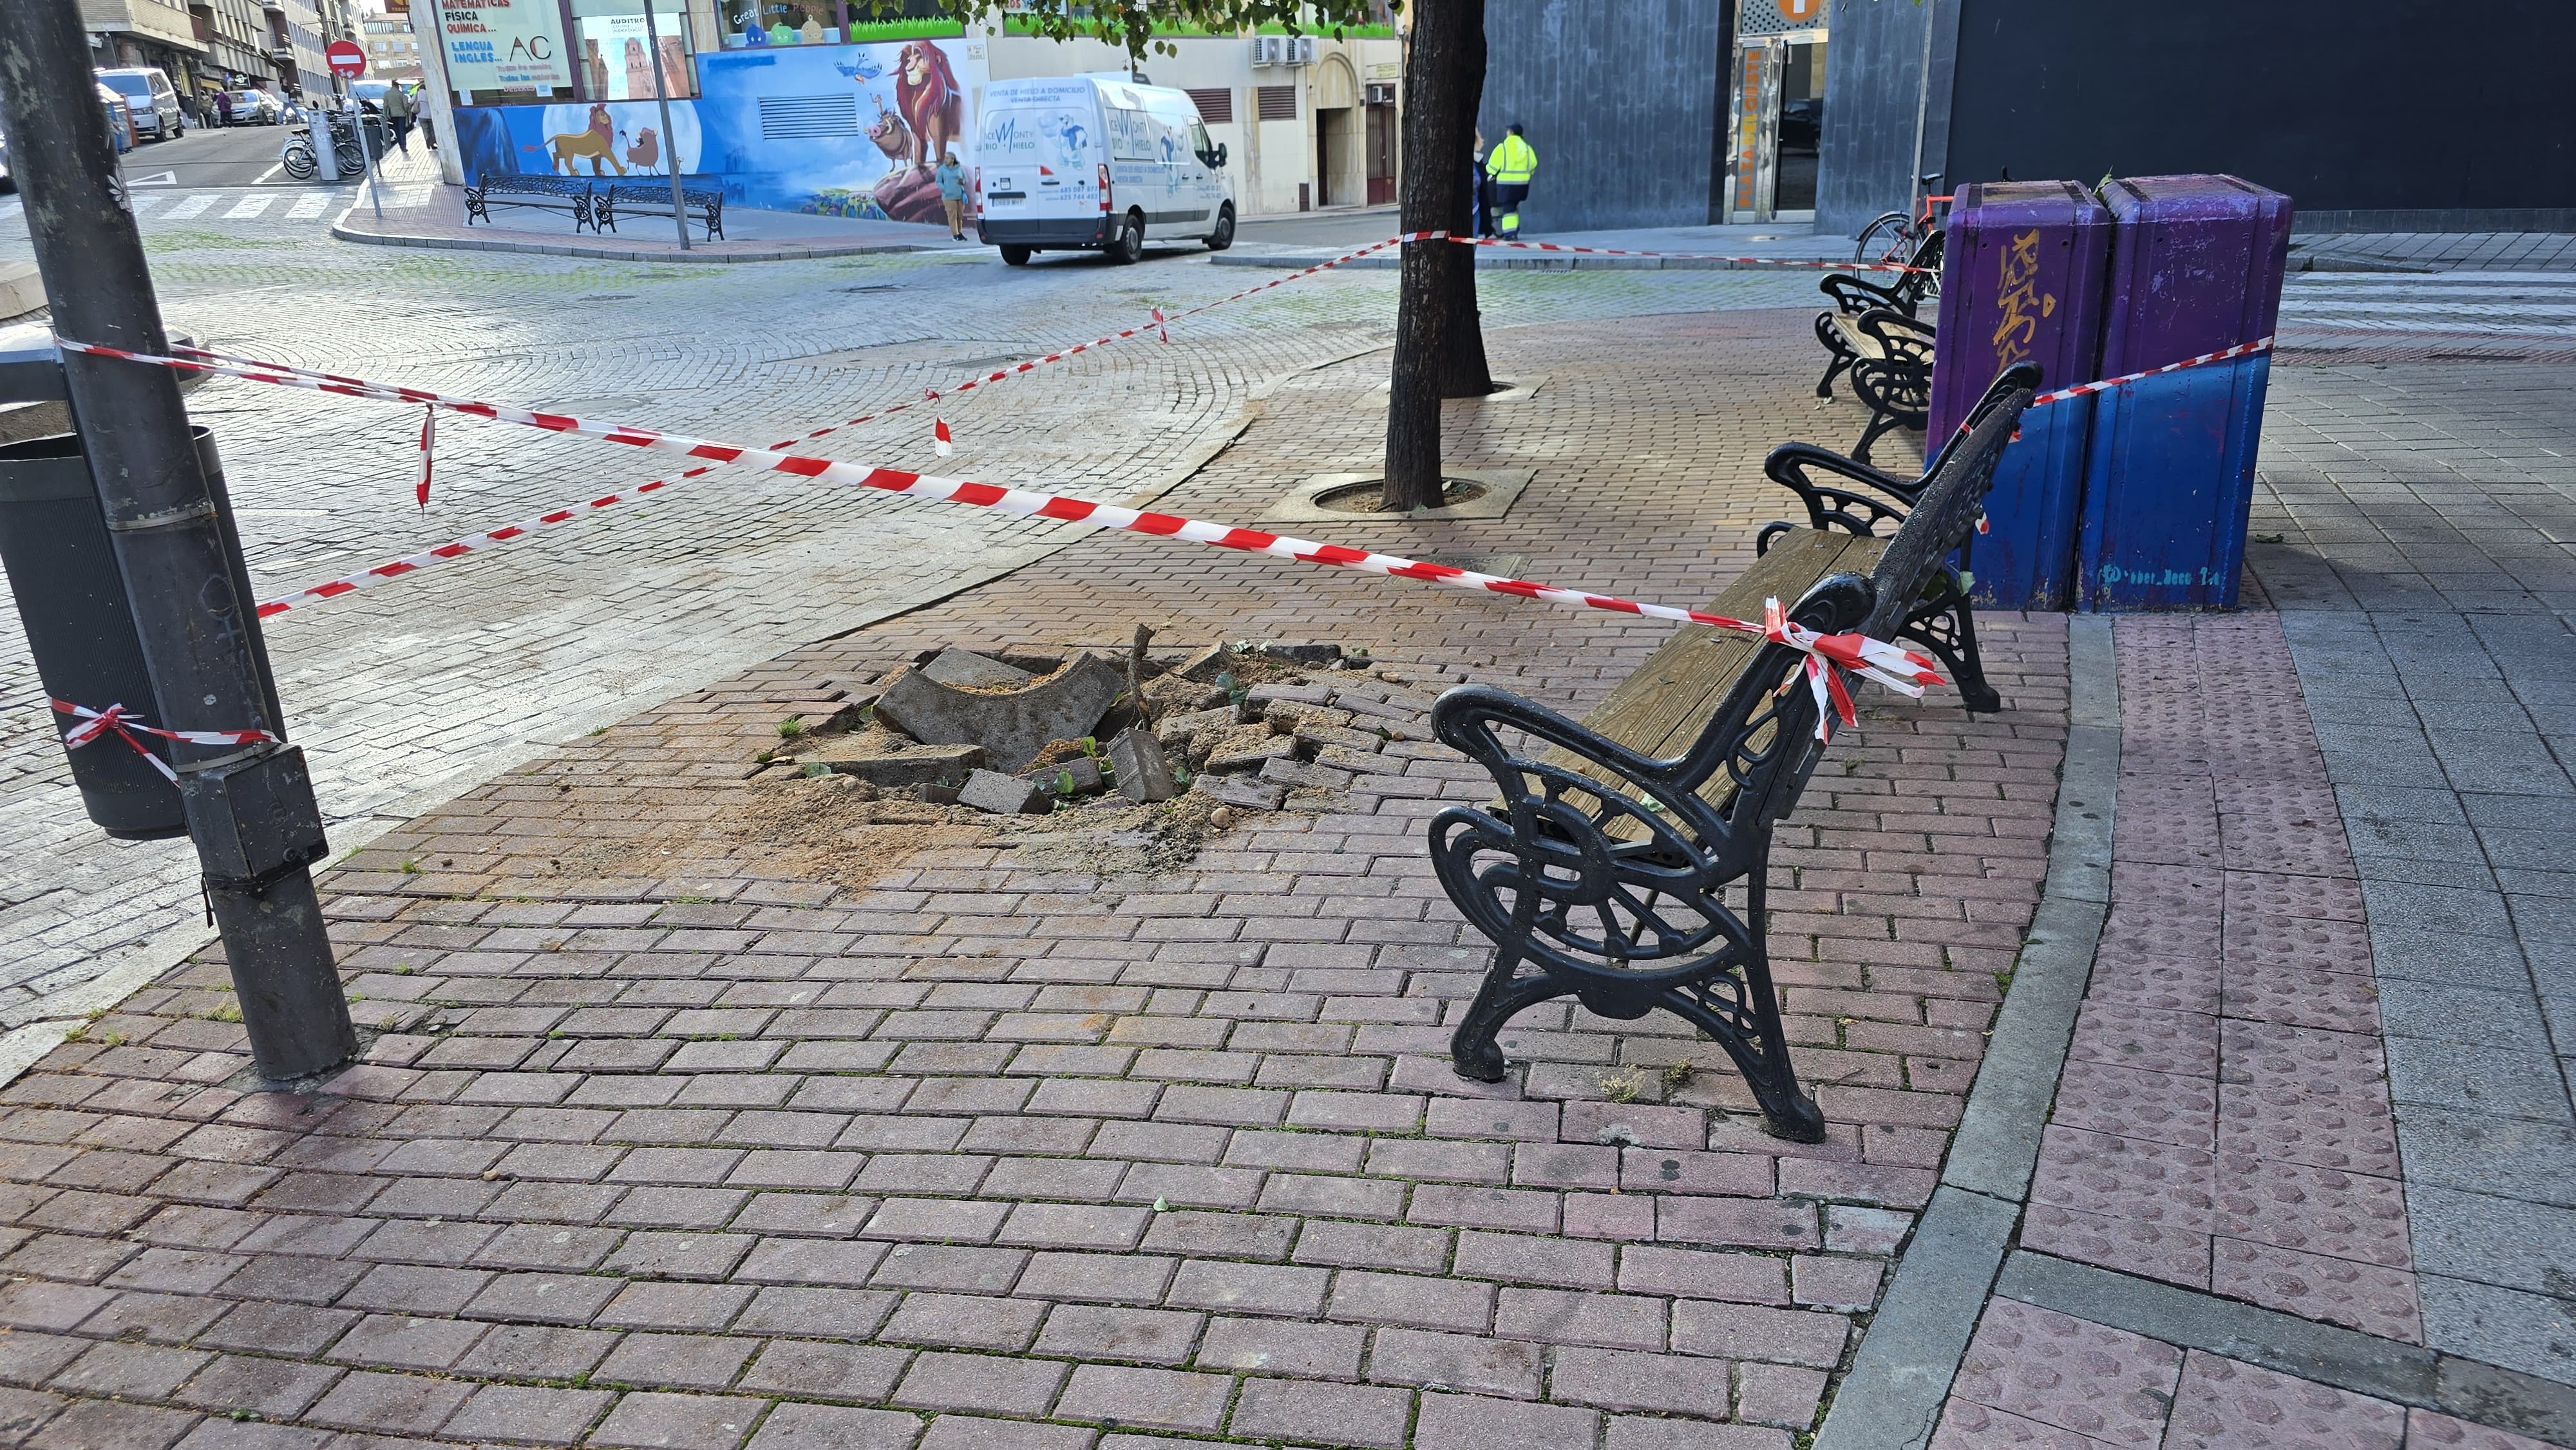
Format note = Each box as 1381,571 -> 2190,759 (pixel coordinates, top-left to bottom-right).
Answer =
1994,613 -> 2424,1350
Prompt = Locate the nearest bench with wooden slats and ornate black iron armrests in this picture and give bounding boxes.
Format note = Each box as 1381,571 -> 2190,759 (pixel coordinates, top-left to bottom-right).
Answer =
1430,363 -> 2038,1144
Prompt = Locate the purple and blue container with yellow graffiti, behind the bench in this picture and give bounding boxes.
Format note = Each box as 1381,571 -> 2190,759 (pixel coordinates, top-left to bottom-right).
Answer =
1924,180 -> 2110,610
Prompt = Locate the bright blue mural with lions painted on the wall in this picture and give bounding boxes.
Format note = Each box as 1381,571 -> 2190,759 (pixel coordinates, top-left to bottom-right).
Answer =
456,39 -> 987,221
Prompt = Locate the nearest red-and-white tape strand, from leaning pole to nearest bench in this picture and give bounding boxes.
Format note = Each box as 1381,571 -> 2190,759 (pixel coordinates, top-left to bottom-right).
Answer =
57,340 -> 1942,729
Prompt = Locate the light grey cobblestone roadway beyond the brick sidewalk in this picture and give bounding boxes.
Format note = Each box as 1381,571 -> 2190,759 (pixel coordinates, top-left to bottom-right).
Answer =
0,188 -> 1811,1025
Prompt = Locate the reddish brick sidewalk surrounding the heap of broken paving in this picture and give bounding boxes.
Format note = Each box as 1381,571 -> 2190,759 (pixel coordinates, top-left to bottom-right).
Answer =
0,314 -> 2066,1450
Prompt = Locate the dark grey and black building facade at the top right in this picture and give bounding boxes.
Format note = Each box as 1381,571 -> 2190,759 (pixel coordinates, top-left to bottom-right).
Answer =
1479,0 -> 2576,232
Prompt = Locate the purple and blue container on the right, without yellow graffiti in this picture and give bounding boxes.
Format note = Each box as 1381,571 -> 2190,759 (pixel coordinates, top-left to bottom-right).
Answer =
2076,175 -> 2290,610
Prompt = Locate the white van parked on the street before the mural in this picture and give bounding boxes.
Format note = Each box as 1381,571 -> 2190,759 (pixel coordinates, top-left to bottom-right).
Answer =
974,72 -> 1234,268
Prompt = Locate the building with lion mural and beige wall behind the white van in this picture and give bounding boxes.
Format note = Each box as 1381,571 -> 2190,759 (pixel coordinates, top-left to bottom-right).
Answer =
417,0 -> 1401,221
